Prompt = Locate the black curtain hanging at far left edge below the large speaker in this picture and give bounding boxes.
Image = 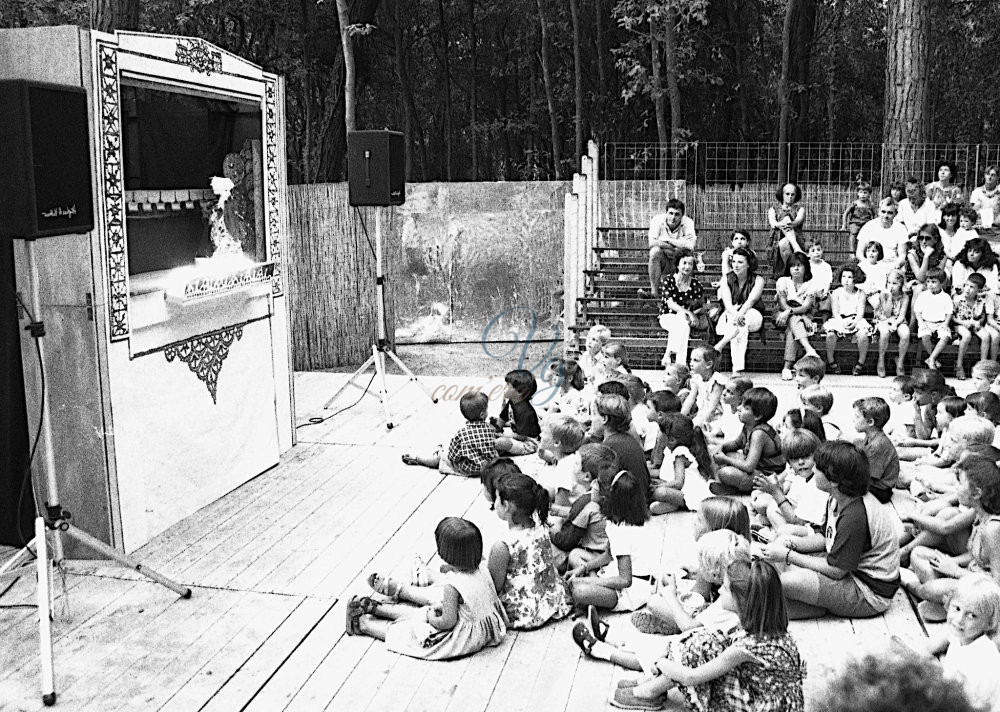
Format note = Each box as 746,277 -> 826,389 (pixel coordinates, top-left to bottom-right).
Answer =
0,240 -> 34,547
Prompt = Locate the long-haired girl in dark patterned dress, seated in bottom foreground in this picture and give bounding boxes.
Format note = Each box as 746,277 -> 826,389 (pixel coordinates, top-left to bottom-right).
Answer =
611,561 -> 805,712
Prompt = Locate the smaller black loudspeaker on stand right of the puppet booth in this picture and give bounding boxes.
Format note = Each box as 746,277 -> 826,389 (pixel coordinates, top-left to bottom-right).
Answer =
347,131 -> 406,205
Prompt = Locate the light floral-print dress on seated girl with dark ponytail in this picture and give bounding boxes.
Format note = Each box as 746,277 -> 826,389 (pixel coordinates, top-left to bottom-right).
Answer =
500,524 -> 573,630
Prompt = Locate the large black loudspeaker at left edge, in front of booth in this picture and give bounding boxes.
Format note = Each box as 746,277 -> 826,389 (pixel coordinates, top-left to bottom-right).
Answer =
0,80 -> 94,239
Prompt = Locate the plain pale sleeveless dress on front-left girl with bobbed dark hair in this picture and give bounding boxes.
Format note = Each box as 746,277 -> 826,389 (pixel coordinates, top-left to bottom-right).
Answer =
385,565 -> 507,660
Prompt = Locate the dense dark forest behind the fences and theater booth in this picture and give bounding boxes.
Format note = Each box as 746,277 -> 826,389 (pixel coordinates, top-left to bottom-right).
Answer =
0,0 -> 1000,183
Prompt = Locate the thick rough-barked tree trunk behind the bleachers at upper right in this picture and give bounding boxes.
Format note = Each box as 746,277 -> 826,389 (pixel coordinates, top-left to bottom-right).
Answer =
882,0 -> 930,182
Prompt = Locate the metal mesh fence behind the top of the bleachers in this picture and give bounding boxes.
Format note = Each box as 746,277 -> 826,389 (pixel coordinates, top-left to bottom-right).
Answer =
598,143 -> 1000,236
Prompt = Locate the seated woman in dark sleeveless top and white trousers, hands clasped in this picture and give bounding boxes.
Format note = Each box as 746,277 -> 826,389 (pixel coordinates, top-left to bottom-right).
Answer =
714,249 -> 764,373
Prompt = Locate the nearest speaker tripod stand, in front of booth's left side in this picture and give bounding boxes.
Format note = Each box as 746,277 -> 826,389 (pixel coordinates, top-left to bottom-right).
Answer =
0,240 -> 191,706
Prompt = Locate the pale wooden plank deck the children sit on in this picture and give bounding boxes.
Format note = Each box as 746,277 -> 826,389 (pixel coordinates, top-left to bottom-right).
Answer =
0,373 -> 936,712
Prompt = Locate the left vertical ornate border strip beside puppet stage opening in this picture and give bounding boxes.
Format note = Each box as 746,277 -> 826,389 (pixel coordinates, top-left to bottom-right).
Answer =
97,42 -> 130,341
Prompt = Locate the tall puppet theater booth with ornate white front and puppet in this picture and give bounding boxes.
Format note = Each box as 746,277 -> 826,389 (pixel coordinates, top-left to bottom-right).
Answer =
0,27 -> 294,558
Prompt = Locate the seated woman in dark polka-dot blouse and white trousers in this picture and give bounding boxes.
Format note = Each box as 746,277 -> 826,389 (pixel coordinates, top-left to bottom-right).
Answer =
659,248 -> 708,366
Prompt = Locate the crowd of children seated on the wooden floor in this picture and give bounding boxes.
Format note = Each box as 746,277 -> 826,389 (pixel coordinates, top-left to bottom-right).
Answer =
347,328 -> 1000,712
